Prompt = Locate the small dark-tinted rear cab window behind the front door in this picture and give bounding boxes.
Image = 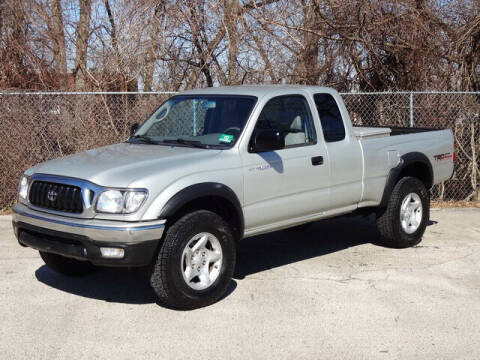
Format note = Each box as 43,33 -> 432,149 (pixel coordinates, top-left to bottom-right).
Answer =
313,94 -> 345,142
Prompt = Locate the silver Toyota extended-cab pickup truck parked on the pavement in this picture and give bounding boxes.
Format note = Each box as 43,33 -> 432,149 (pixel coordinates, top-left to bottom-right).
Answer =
13,86 -> 455,309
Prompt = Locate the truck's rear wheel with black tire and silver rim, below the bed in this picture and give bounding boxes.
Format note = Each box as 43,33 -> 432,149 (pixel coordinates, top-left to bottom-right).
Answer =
377,177 -> 430,249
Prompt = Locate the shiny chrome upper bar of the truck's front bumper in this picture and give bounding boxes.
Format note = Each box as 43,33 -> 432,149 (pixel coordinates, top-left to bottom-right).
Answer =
12,204 -> 166,244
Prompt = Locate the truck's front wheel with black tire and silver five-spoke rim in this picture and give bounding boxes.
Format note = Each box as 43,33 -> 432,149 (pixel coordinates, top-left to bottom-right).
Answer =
150,210 -> 236,310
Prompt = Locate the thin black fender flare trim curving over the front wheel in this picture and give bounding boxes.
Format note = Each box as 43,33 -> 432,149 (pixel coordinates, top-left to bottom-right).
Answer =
159,182 -> 245,238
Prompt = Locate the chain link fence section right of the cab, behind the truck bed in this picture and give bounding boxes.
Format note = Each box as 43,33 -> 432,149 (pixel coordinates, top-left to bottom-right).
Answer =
342,92 -> 480,201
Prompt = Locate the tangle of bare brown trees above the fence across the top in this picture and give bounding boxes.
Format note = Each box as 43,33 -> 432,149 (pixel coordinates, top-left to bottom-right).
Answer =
0,0 -> 480,91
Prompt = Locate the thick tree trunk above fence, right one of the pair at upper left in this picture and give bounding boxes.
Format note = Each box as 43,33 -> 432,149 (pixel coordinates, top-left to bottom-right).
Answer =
73,0 -> 92,91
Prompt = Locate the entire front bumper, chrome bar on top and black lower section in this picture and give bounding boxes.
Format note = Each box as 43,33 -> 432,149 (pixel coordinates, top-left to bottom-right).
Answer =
12,204 -> 165,266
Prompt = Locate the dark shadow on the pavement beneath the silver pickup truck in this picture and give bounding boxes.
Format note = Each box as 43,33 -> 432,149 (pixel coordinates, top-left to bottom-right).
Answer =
35,217 -> 435,304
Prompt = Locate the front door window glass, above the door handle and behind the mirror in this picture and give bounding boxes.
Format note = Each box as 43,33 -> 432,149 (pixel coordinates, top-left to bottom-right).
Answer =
254,95 -> 316,147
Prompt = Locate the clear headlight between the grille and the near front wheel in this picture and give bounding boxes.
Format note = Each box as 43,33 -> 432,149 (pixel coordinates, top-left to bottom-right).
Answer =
96,190 -> 147,214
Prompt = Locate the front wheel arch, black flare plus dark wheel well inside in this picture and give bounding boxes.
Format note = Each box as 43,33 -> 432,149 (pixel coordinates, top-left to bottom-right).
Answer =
159,182 -> 244,240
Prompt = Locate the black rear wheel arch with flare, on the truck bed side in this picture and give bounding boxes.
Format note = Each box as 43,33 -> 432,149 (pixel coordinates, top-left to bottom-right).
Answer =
379,152 -> 433,207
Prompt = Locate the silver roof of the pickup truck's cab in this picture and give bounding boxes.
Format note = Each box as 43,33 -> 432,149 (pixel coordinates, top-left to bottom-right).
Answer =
181,85 -> 335,97
